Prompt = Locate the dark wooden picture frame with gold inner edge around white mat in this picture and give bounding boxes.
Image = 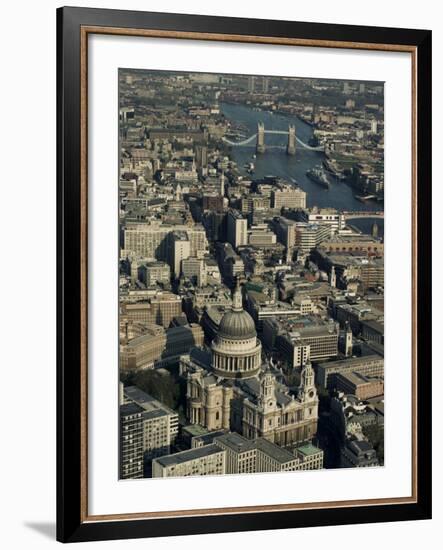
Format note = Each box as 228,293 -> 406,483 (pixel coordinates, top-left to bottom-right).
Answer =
57,8 -> 431,542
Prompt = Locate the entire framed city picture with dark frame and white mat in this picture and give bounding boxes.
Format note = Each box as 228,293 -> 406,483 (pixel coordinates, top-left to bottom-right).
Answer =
57,7 -> 432,542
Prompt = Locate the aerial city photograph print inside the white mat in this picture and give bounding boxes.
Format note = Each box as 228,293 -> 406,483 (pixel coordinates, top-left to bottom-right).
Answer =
116,68 -> 384,479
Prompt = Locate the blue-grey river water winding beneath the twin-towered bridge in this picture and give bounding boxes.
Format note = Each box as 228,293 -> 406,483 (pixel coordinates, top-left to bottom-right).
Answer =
220,103 -> 384,236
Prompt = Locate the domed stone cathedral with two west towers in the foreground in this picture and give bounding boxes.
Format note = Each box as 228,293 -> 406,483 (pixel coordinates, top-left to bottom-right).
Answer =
180,286 -> 318,447
